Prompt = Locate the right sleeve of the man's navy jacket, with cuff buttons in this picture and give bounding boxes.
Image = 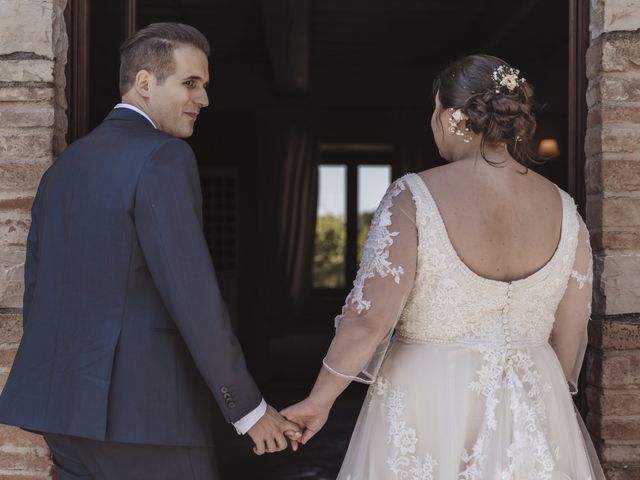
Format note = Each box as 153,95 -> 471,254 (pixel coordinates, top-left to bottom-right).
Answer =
135,139 -> 262,422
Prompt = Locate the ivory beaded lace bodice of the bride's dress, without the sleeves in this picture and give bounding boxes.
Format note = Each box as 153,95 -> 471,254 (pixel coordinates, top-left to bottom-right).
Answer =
396,174 -> 579,343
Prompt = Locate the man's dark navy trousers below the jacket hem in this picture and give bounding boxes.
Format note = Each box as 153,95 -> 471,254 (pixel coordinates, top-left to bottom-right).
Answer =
44,433 -> 219,480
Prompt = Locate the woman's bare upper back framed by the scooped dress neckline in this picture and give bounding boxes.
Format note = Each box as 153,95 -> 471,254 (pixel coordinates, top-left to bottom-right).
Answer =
420,158 -> 562,281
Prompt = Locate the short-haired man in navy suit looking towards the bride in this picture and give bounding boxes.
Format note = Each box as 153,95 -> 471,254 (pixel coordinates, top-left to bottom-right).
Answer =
0,23 -> 299,480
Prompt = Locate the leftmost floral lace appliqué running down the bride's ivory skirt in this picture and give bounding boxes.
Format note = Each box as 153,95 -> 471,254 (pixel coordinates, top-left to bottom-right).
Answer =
368,377 -> 438,480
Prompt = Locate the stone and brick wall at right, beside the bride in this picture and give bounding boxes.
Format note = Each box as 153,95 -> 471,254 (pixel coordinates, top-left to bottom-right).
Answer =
585,0 -> 640,480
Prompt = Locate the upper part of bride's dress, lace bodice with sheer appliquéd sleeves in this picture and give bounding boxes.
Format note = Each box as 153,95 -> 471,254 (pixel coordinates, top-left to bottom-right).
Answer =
324,174 -> 593,385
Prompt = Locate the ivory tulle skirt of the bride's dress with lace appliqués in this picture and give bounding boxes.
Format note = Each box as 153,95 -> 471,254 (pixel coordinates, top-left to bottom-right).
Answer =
338,339 -> 605,480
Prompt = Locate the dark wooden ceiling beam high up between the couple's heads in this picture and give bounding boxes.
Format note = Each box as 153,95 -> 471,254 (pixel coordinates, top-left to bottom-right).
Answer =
261,0 -> 310,95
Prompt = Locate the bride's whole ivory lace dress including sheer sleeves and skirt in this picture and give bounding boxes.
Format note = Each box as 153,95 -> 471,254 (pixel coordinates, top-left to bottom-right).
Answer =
324,174 -> 604,480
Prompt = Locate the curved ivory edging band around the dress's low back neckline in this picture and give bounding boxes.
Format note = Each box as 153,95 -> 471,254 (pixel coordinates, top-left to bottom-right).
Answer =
412,173 -> 568,288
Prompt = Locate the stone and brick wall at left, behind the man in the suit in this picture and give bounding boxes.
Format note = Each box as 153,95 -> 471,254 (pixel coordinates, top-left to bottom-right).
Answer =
0,0 -> 67,480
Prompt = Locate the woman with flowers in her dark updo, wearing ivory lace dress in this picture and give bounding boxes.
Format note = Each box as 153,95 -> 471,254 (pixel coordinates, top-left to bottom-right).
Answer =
282,55 -> 604,480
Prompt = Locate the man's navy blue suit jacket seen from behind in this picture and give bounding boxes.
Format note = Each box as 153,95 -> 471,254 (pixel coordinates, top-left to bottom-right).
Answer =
0,108 -> 262,446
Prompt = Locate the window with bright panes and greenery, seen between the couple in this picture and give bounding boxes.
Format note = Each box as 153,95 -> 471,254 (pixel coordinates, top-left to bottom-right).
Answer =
313,145 -> 392,290
